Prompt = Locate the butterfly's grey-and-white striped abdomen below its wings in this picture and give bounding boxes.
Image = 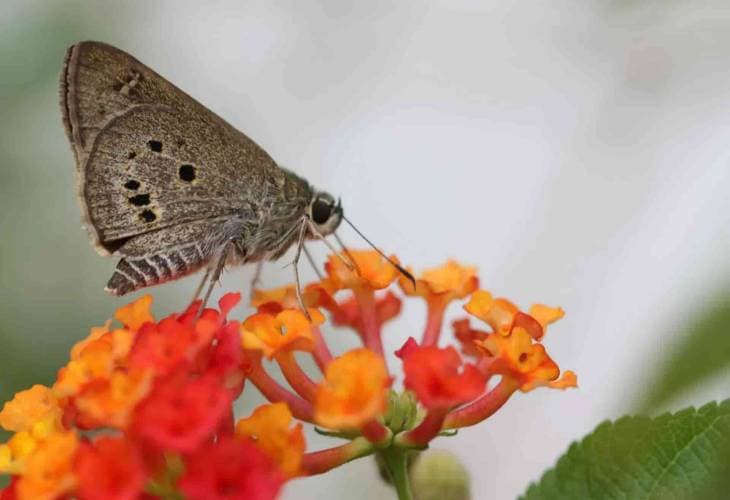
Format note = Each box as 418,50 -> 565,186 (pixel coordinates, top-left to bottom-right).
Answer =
106,245 -> 209,295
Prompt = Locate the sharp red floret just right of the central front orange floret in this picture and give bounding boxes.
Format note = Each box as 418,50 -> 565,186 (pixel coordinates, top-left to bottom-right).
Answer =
399,339 -> 486,410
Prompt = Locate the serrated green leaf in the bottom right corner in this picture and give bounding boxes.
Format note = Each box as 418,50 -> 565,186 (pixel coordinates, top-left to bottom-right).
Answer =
523,400 -> 730,500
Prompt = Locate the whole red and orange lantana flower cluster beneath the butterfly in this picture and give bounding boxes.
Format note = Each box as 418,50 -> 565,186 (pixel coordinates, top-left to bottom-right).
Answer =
0,250 -> 577,500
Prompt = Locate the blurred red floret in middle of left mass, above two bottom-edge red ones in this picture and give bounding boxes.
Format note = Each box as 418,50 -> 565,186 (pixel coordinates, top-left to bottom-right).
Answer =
132,373 -> 233,453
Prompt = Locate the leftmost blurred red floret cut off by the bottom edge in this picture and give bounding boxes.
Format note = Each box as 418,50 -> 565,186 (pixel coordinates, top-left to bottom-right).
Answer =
74,437 -> 146,500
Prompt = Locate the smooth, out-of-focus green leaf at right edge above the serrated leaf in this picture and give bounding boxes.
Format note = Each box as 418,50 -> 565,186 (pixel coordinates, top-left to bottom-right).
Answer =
640,291 -> 730,413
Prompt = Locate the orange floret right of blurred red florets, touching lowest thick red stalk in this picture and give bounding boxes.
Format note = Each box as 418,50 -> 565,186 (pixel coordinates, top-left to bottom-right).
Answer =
236,403 -> 305,477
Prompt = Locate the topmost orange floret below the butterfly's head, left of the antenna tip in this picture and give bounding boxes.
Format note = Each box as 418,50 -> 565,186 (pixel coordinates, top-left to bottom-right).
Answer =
325,250 -> 399,290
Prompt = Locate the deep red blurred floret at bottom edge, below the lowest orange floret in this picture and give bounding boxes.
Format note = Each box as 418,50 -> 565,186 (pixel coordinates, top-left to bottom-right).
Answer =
178,437 -> 284,500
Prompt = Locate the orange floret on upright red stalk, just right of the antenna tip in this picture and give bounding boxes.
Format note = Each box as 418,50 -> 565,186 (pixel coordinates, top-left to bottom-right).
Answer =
398,260 -> 479,304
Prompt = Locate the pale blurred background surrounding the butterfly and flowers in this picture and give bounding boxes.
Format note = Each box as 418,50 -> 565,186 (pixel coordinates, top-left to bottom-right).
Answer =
0,0 -> 730,499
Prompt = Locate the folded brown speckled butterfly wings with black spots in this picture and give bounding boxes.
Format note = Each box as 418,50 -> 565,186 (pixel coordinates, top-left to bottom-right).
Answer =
60,42 -> 282,255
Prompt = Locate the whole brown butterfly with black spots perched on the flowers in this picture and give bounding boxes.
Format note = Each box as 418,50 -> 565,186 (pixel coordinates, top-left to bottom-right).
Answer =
60,42 -> 405,305
